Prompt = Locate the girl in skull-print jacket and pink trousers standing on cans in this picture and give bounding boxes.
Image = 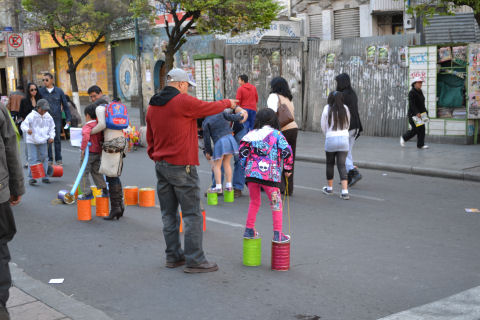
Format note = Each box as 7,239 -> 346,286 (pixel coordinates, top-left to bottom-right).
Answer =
240,108 -> 293,243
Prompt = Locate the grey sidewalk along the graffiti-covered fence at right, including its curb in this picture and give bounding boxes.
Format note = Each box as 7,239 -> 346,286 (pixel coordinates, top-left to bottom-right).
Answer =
296,131 -> 480,181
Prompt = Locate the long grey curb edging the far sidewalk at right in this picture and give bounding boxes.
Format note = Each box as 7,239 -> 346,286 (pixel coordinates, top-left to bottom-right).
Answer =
295,154 -> 480,182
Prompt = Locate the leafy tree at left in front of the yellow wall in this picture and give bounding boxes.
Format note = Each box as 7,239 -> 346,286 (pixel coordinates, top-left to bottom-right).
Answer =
22,0 -> 147,105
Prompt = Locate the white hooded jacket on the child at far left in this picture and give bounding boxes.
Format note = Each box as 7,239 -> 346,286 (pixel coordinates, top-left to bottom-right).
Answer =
20,110 -> 55,144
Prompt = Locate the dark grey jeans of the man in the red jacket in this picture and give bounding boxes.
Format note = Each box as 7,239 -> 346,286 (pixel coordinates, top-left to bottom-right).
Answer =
155,161 -> 206,267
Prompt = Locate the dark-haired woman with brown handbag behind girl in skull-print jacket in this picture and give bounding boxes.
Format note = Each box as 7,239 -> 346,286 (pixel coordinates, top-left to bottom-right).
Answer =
267,77 -> 298,196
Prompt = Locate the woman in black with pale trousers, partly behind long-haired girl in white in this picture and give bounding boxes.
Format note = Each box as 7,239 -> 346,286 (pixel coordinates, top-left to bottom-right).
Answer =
335,73 -> 363,187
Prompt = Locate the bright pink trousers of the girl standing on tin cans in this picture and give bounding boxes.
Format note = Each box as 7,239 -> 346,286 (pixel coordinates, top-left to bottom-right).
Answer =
246,182 -> 282,231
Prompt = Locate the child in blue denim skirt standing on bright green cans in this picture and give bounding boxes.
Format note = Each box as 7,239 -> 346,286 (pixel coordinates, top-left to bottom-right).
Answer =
202,110 -> 248,194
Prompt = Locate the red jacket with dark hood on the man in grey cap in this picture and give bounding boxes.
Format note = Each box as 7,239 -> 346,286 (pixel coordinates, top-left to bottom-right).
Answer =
147,86 -> 231,166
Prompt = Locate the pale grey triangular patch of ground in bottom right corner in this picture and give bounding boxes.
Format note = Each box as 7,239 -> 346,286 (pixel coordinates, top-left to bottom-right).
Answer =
379,287 -> 480,320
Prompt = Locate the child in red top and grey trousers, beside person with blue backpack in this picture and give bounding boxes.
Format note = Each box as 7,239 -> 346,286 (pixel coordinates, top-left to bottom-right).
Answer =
80,104 -> 108,199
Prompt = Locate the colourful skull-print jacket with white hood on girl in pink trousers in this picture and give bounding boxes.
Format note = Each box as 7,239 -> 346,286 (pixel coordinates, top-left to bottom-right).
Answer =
239,126 -> 293,187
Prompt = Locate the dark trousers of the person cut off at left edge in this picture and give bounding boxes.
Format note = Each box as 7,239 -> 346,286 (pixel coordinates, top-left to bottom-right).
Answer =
0,201 -> 17,310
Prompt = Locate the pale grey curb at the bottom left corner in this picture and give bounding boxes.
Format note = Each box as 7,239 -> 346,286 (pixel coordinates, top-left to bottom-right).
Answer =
9,263 -> 113,320
